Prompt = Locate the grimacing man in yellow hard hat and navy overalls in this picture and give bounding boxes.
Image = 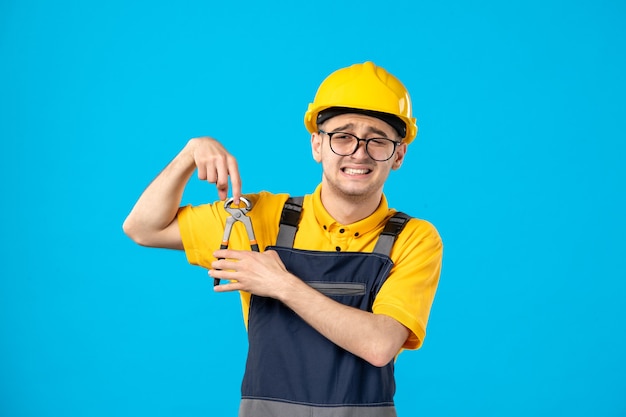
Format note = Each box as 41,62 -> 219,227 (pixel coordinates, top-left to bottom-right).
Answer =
124,62 -> 442,417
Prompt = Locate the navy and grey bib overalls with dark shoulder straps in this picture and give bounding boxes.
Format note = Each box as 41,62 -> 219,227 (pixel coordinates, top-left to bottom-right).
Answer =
239,199 -> 409,417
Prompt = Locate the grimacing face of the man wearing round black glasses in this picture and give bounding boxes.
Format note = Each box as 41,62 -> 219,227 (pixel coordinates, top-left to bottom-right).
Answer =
311,114 -> 407,202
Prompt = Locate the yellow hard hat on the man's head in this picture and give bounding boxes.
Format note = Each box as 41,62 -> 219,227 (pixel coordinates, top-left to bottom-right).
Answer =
304,62 -> 417,143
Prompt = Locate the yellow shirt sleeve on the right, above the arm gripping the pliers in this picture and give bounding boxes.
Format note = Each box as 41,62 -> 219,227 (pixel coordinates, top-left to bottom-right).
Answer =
373,219 -> 443,349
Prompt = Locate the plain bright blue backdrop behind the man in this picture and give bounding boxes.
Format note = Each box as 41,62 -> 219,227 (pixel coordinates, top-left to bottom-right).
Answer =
0,0 -> 626,417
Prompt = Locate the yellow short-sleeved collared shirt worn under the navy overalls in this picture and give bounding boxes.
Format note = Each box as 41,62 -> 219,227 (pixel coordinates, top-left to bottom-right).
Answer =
178,185 -> 443,349
